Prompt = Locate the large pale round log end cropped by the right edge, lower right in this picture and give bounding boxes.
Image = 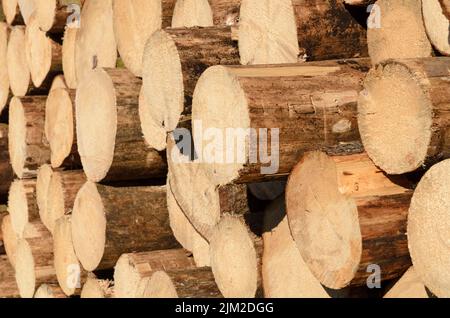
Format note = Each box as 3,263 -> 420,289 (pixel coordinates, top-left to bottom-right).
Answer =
408,160 -> 450,297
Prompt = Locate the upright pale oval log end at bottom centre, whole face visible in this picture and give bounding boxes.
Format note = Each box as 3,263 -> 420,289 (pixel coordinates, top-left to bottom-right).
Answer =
210,216 -> 258,298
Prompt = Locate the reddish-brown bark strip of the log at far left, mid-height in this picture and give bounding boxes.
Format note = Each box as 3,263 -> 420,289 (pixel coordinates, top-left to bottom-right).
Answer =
12,96 -> 50,178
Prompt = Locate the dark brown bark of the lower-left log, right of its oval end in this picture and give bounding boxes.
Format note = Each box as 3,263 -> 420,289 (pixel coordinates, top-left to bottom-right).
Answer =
97,185 -> 179,269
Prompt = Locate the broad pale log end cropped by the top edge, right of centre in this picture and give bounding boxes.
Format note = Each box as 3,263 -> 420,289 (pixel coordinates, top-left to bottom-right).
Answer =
239,0 -> 300,65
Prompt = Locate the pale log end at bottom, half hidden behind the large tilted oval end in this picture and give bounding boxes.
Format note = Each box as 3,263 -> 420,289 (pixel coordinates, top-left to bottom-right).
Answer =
262,195 -> 330,298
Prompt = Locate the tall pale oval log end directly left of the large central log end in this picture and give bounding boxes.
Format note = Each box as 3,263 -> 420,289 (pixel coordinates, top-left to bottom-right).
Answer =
140,31 -> 184,141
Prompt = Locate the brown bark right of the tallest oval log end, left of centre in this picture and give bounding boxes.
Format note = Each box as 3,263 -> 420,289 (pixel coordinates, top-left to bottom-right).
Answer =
102,69 -> 167,181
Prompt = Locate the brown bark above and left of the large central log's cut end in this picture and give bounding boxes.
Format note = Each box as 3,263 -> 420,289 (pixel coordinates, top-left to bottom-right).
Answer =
164,27 -> 240,121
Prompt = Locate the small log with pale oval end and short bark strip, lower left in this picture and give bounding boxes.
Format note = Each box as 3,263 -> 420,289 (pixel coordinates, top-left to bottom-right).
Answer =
8,179 -> 40,237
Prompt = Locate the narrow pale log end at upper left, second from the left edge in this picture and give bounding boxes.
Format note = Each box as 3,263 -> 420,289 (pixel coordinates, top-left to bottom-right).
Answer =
6,26 -> 30,96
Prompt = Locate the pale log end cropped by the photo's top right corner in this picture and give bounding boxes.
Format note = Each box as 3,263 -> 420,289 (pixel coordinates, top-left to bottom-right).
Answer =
422,0 -> 450,55
